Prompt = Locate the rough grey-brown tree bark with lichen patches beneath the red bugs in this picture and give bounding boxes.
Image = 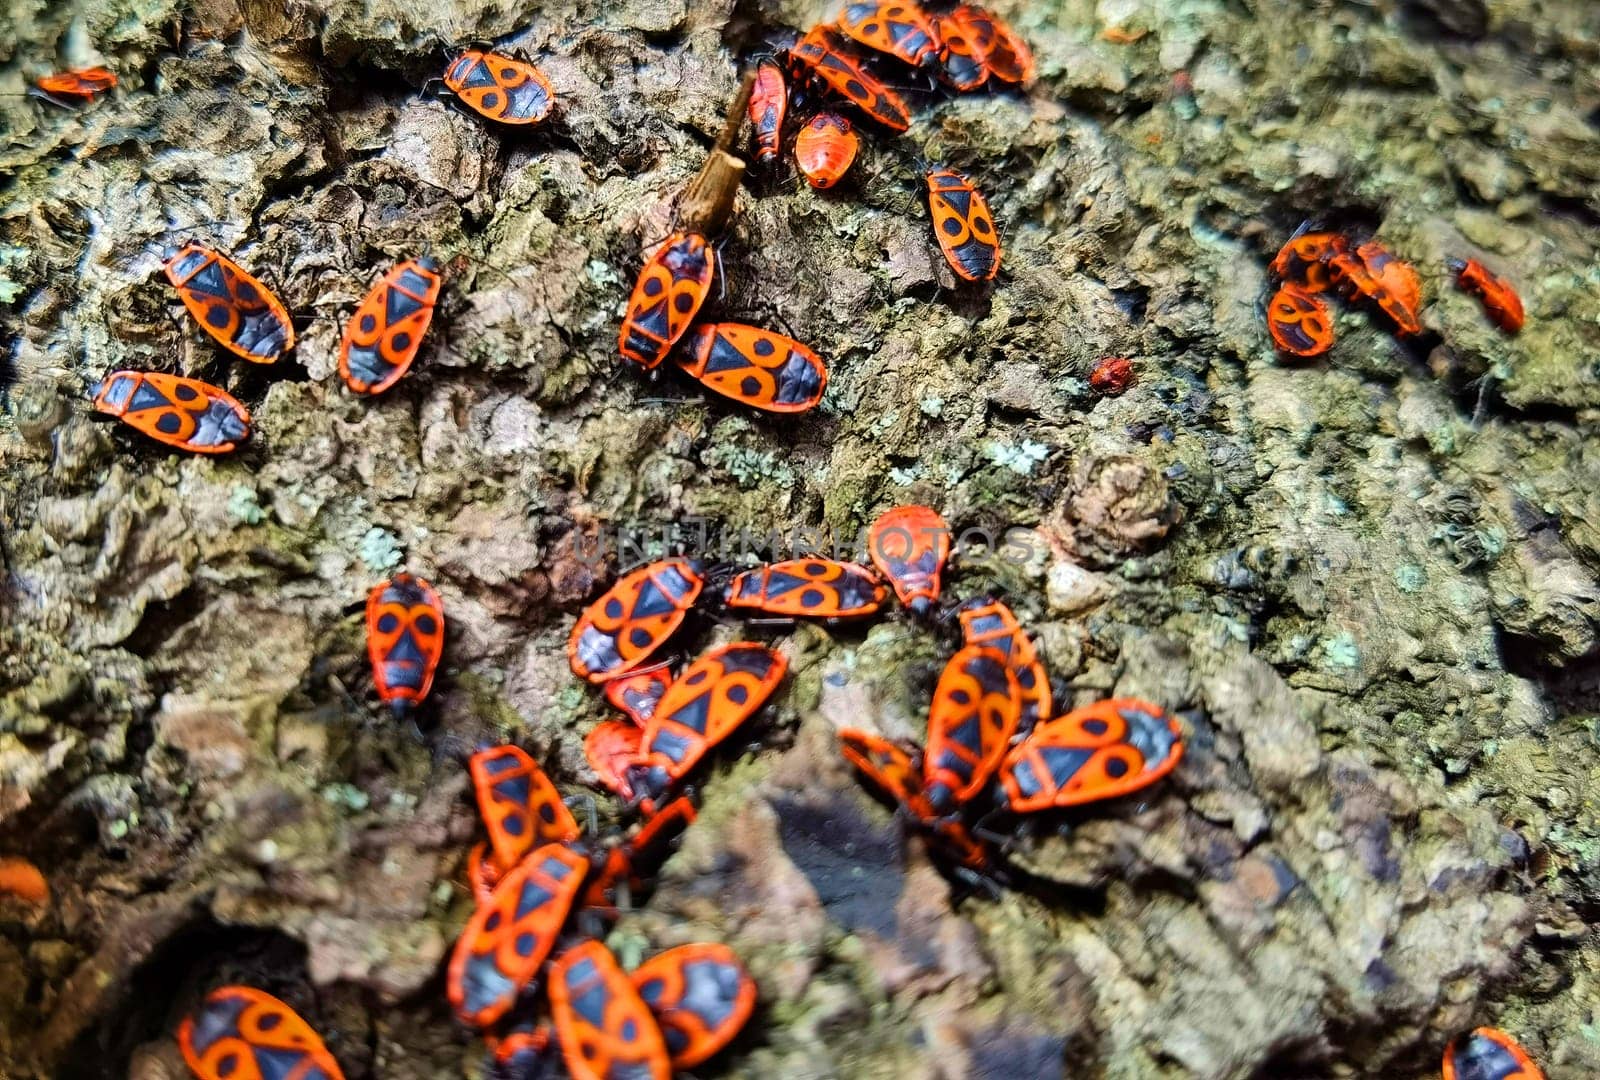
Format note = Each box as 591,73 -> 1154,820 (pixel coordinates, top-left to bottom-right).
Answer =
0,0 -> 1600,1080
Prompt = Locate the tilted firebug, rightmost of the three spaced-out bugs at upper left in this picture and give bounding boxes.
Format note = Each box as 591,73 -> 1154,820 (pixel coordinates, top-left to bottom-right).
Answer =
339,256 -> 440,394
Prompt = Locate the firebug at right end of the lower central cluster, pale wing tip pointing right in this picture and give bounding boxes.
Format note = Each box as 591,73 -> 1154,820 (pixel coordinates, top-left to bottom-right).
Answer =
1000,698 -> 1184,814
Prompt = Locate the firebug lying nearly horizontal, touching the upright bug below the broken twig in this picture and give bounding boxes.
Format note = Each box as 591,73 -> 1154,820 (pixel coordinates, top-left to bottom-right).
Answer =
677,323 -> 827,413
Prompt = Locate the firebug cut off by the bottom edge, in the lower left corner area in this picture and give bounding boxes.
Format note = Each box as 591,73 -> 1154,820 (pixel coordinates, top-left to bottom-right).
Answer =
178,986 -> 344,1080
